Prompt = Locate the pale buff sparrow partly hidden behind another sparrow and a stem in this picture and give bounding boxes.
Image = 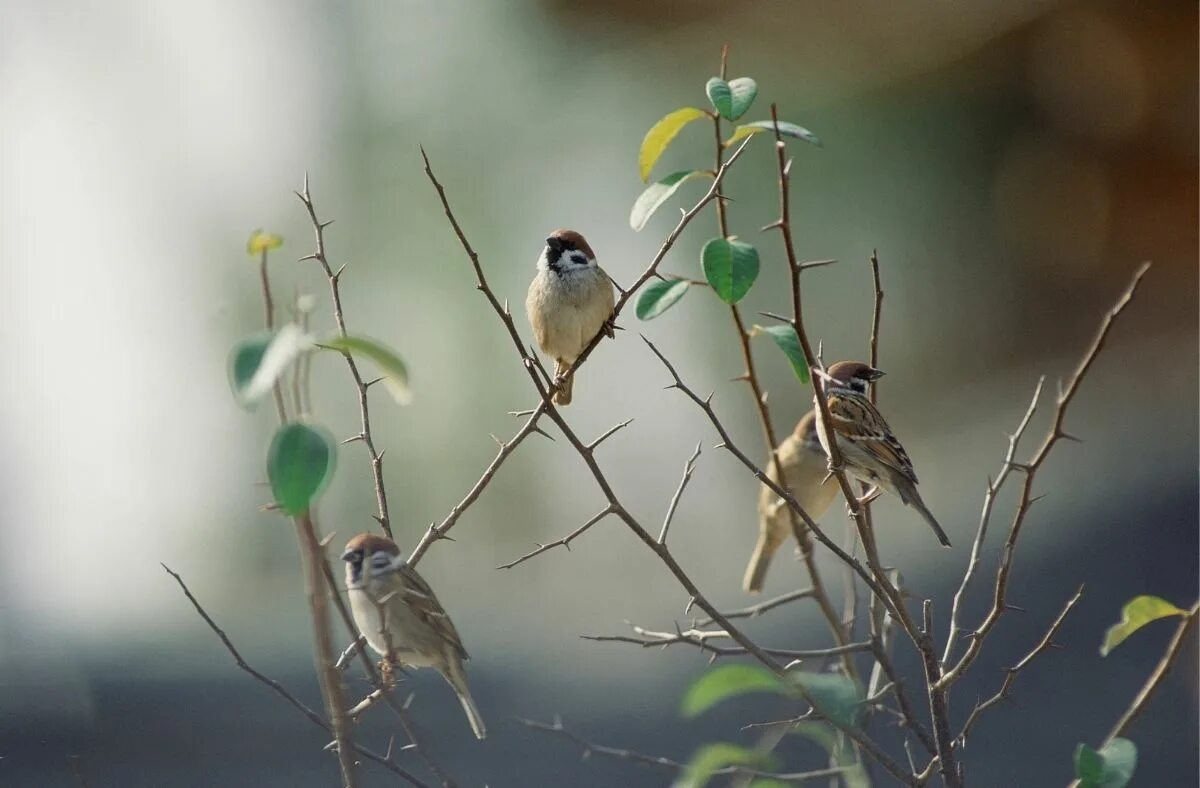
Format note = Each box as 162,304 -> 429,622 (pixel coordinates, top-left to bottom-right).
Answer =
742,410 -> 838,594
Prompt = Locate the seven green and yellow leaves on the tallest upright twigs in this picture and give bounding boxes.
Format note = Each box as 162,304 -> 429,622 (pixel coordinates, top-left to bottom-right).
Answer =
629,69 -> 821,383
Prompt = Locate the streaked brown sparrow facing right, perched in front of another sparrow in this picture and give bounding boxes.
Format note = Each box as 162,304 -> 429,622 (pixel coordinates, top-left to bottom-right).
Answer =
817,361 -> 950,547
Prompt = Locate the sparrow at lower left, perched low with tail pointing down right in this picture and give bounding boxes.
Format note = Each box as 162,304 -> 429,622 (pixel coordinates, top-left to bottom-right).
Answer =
342,534 -> 487,739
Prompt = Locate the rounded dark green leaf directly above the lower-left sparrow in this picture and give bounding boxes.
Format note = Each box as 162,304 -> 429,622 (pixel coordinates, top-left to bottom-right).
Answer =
266,422 -> 336,516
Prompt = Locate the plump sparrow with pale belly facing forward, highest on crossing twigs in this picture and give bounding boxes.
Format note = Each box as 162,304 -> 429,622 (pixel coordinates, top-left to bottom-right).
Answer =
526,230 -> 614,405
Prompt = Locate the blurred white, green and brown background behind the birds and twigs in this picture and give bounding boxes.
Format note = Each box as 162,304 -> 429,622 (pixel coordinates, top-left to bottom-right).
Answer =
0,0 -> 1198,787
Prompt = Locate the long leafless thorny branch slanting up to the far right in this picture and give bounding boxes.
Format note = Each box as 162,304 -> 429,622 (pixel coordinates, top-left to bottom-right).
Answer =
938,263 -> 1150,688
